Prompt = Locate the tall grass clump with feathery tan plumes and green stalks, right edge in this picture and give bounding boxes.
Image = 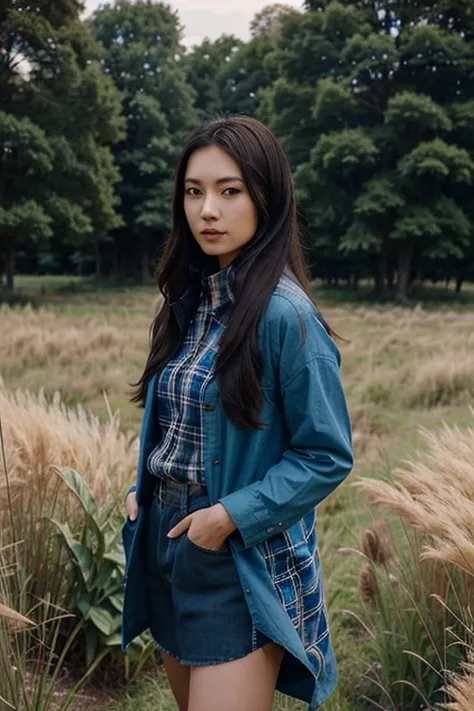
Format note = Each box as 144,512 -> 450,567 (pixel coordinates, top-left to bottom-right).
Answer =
357,410 -> 474,711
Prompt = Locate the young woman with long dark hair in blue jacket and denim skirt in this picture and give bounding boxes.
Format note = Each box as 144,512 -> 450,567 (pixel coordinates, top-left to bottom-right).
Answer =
122,115 -> 353,711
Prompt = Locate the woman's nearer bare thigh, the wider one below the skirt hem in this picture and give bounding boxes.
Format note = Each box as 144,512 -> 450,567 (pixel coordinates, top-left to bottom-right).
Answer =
188,642 -> 283,711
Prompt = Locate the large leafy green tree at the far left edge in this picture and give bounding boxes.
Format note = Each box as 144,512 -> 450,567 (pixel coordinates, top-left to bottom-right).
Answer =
0,0 -> 122,289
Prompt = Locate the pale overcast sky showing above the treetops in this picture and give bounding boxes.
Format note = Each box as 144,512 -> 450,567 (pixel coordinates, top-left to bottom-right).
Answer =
81,0 -> 303,47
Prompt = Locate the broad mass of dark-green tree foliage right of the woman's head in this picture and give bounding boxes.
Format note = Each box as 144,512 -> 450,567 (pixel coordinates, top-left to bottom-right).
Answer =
266,0 -> 474,299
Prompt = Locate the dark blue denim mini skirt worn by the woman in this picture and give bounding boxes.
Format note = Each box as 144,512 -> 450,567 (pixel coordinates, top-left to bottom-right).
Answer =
147,478 -> 271,666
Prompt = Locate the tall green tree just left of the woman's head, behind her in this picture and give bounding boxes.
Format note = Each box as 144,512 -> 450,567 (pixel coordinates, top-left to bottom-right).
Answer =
92,0 -> 198,280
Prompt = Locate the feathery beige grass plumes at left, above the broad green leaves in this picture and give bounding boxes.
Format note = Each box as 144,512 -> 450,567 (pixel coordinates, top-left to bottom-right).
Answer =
0,379 -> 138,504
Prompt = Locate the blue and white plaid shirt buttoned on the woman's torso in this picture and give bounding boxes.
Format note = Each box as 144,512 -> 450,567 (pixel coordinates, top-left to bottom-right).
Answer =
148,266 -> 234,484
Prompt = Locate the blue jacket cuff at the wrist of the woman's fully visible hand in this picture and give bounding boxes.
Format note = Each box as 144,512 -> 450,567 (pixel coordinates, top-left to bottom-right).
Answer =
219,489 -> 286,549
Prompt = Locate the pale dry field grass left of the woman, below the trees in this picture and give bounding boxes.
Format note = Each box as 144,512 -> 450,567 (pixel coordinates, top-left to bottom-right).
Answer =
0,299 -> 154,429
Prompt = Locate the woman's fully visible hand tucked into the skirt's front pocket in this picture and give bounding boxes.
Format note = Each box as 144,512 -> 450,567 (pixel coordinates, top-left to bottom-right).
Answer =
168,504 -> 237,551
